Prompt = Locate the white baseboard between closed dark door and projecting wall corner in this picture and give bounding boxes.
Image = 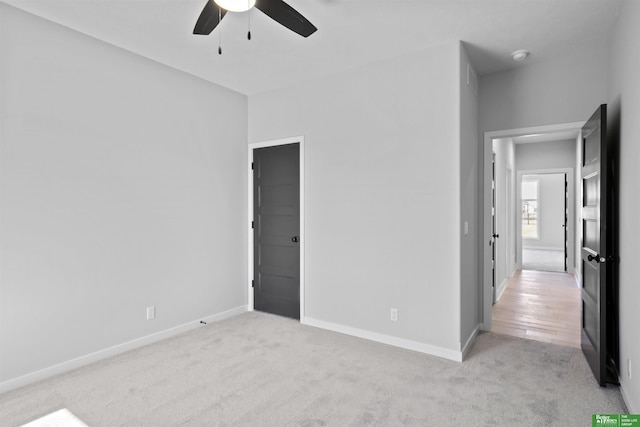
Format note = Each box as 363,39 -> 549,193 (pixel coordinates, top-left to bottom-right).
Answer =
301,317 -> 462,362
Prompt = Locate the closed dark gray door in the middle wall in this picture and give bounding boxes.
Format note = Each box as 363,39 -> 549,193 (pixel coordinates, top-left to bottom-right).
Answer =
253,144 -> 300,319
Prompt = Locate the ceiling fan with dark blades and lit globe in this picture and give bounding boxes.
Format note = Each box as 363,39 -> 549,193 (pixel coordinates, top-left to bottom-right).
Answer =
193,0 -> 317,39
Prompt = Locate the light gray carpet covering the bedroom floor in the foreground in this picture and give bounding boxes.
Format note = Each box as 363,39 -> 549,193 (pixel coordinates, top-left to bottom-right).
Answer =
0,313 -> 624,427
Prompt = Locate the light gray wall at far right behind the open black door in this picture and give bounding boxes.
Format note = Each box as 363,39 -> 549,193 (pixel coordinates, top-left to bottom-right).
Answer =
607,0 -> 640,414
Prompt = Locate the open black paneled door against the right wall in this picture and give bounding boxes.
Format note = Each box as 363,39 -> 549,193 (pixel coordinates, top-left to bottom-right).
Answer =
581,105 -> 618,386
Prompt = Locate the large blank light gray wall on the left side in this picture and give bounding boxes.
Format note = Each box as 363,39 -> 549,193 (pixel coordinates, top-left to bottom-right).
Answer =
0,3 -> 247,385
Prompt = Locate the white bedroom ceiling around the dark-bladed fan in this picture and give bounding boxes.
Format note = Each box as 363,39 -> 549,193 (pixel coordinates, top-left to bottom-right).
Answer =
2,0 -> 620,94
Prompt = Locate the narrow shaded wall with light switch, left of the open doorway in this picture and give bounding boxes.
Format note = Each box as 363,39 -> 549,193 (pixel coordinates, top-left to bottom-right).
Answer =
460,44 -> 481,352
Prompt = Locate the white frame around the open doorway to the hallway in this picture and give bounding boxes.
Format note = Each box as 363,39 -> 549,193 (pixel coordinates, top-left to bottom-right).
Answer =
480,122 -> 584,331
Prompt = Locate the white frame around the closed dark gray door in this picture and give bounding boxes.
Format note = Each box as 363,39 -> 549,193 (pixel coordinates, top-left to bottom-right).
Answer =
247,136 -> 305,322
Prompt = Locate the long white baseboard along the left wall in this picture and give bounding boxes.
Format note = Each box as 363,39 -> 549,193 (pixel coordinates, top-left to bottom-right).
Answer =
0,305 -> 247,393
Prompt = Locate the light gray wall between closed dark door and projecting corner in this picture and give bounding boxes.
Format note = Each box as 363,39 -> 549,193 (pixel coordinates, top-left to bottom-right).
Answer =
249,43 -> 461,353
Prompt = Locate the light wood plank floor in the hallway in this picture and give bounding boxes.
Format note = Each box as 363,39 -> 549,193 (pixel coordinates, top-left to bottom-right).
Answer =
492,270 -> 581,348
